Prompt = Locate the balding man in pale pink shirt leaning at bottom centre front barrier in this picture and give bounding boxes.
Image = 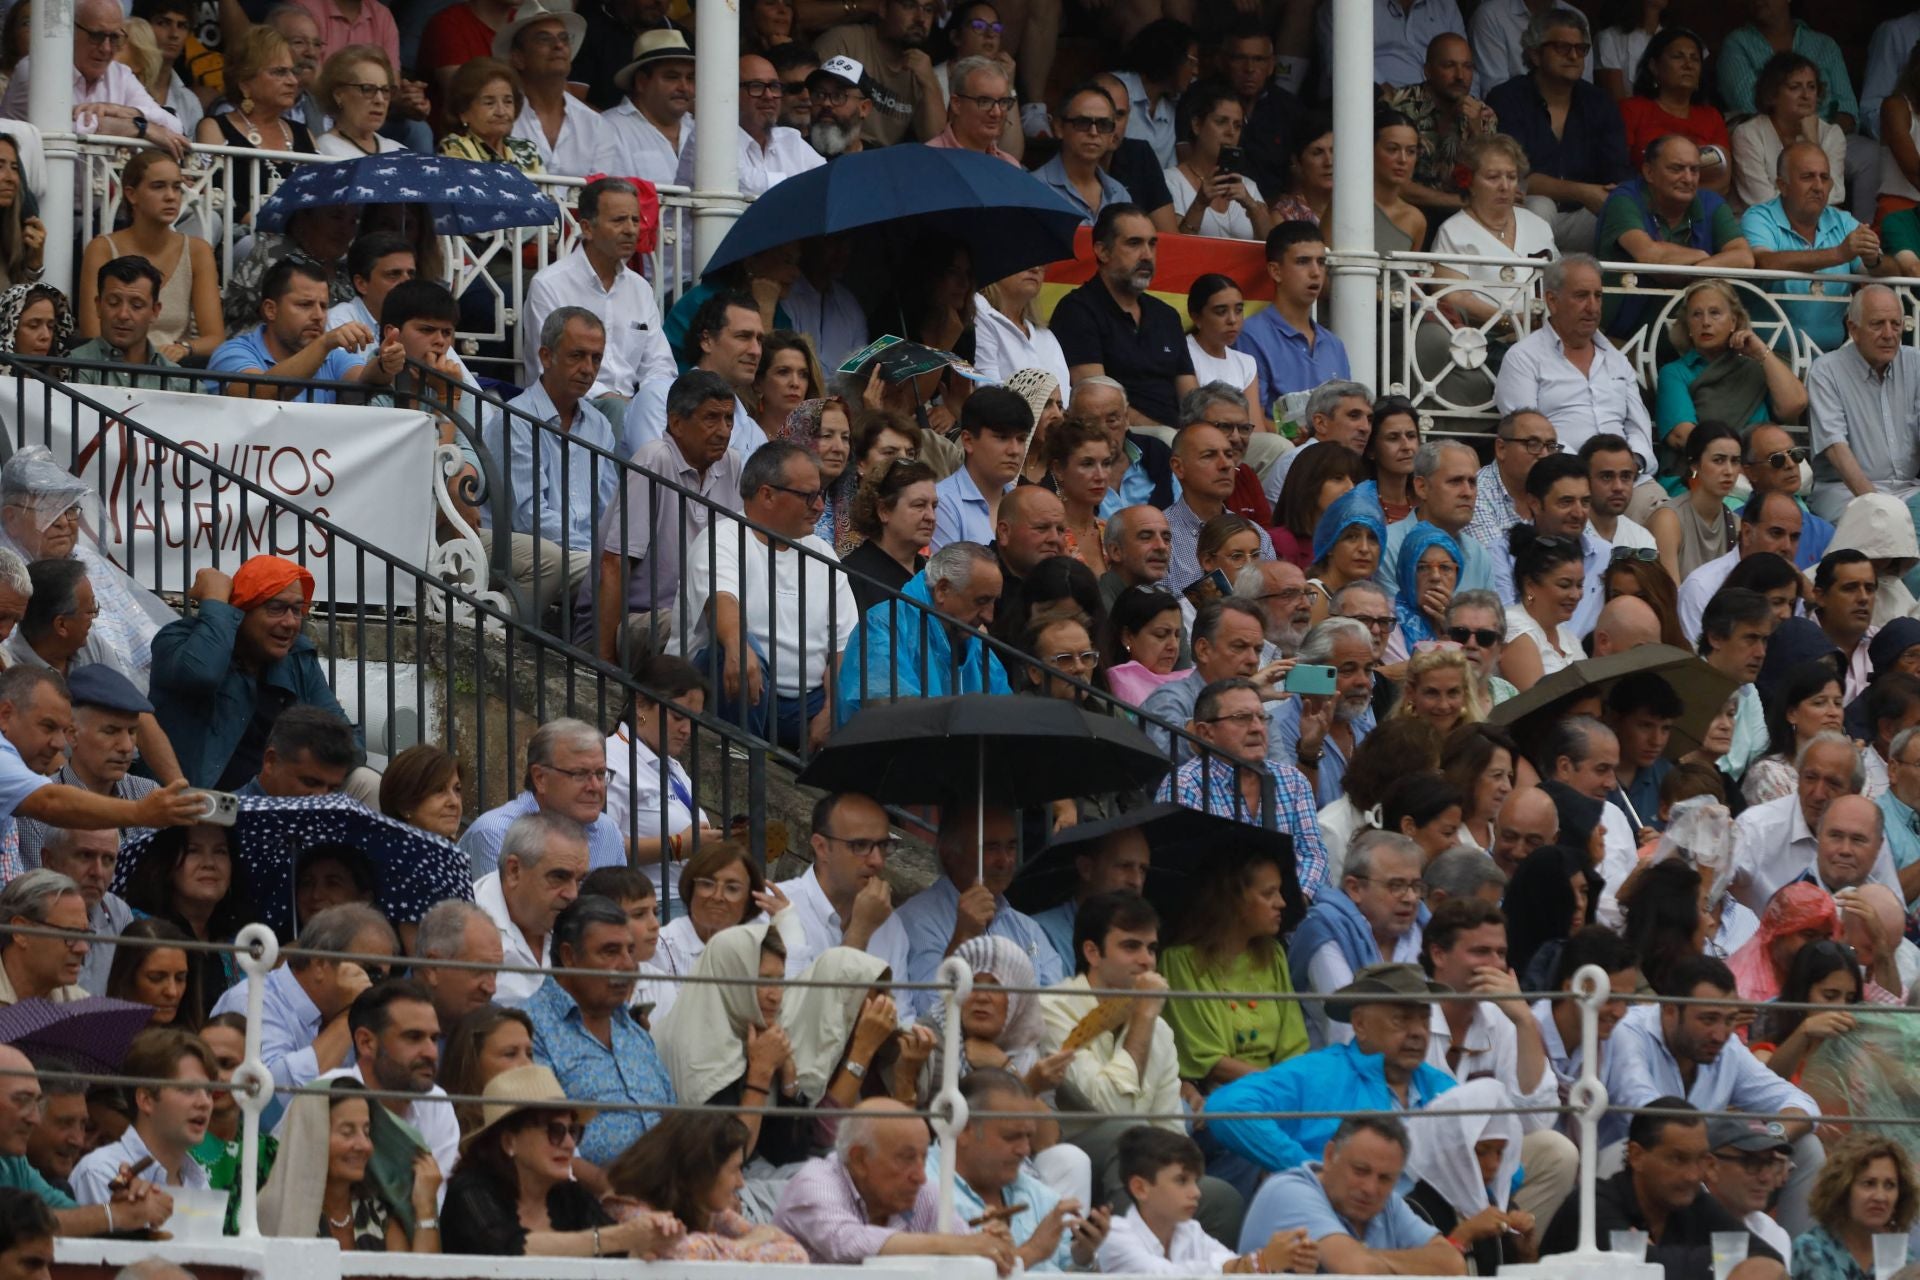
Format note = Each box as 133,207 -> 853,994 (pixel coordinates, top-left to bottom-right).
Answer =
774,1098 -> 1014,1276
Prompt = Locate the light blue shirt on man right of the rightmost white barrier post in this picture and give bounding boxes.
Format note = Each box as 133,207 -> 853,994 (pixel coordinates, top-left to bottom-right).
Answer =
1599,1004 -> 1820,1146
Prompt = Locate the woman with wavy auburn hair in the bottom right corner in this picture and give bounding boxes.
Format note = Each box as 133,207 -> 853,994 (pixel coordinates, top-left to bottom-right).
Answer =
1793,1132 -> 1916,1280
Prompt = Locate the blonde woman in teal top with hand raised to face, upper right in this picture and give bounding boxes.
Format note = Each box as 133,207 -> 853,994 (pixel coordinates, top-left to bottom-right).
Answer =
1653,280 -> 1807,493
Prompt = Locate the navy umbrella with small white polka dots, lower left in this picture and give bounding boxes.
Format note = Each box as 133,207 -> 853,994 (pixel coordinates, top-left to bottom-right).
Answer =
113,794 -> 474,936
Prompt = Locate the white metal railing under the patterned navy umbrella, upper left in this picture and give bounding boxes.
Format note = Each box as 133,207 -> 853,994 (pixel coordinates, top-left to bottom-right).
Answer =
75,134 -> 693,372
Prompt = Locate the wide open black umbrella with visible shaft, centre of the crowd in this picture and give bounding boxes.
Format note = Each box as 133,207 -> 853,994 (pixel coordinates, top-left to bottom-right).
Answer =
795,693 -> 1167,882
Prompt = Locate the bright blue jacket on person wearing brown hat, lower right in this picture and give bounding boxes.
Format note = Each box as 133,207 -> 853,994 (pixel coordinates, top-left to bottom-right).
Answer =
1206,1044 -> 1457,1173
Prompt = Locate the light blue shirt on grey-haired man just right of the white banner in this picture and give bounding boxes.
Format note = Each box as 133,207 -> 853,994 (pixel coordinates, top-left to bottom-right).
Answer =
480,382 -> 622,551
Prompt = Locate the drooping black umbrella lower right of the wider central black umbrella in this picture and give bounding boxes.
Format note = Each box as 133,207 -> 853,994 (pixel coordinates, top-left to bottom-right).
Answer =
1006,804 -> 1308,933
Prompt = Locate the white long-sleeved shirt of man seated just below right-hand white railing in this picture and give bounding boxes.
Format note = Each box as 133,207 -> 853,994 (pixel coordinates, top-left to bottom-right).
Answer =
1494,324 -> 1653,476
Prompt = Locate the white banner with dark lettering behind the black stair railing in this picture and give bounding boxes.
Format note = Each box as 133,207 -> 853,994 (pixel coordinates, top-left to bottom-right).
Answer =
0,378 -> 438,604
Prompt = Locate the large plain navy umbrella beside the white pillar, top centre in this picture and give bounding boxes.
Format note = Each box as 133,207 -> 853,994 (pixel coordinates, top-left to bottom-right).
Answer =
707,144 -> 1081,280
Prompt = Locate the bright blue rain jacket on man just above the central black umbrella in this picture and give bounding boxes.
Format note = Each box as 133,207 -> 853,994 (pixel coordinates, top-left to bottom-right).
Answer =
833,570 -> 1014,723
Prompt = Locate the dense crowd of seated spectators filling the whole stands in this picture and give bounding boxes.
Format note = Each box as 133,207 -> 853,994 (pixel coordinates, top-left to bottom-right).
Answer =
0,0 -> 1920,1280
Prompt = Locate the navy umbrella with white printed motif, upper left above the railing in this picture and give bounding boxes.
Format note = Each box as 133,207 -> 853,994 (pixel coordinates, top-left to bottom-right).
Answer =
253,152 -> 561,236
